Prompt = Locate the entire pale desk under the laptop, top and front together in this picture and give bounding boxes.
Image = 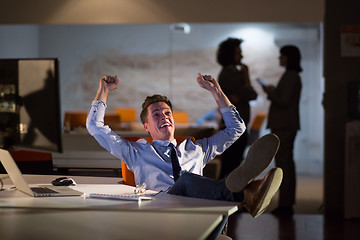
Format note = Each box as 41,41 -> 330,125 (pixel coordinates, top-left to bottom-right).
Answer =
0,175 -> 238,239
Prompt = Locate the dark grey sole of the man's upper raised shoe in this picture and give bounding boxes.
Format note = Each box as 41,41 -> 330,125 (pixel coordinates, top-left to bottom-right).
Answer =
225,133 -> 280,192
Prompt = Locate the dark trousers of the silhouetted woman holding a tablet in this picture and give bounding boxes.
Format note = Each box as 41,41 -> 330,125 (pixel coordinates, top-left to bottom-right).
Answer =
271,129 -> 297,207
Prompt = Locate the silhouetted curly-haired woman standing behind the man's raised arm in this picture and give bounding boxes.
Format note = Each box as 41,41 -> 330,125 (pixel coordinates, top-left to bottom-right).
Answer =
217,38 -> 257,178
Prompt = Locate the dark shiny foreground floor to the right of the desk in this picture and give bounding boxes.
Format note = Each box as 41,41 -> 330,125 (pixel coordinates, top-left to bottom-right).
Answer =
227,213 -> 360,240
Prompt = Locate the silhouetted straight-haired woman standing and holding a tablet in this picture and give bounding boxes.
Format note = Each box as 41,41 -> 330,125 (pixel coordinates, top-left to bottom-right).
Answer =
263,45 -> 302,215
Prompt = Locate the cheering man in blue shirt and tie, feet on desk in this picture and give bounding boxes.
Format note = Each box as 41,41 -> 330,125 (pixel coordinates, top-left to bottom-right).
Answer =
86,73 -> 282,217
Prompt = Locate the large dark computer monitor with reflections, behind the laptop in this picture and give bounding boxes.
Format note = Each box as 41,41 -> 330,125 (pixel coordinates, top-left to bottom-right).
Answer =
0,59 -> 62,152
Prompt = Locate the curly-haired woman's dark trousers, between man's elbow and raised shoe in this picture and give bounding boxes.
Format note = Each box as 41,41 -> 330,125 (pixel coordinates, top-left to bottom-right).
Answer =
220,131 -> 249,178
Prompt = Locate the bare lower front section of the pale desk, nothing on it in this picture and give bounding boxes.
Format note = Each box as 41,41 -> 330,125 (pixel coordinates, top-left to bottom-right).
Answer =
0,208 -> 222,240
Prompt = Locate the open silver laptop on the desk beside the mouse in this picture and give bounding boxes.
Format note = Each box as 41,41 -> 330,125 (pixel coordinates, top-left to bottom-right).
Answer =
0,149 -> 83,197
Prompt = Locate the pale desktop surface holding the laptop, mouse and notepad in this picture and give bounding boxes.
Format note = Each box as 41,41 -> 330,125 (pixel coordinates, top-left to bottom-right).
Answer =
0,174 -> 240,215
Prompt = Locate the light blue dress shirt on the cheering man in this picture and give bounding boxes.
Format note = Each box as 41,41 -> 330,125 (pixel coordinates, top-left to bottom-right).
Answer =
86,101 -> 246,191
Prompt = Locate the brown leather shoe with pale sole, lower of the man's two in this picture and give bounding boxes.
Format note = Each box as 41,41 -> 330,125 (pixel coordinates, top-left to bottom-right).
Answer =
243,168 -> 283,218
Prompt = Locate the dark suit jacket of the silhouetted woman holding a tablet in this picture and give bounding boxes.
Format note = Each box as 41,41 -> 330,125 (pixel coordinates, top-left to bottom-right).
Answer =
267,71 -> 302,130
